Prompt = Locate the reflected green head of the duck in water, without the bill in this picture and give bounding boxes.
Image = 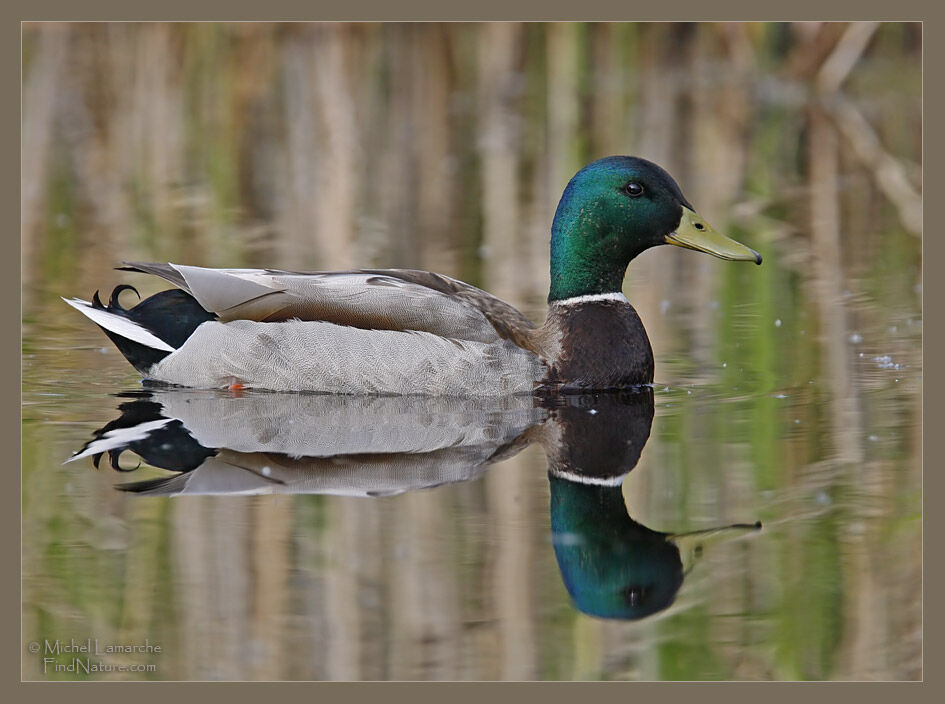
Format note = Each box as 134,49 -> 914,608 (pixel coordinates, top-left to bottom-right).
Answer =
549,475 -> 683,619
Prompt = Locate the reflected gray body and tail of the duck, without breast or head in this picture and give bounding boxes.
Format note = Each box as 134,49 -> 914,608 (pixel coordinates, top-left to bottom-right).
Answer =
69,389 -> 547,496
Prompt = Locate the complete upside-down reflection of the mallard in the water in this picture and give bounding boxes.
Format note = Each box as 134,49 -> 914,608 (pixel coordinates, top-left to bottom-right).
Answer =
70,387 -> 761,619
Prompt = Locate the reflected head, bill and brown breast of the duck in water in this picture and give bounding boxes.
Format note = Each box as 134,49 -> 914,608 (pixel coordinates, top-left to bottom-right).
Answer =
542,394 -> 761,619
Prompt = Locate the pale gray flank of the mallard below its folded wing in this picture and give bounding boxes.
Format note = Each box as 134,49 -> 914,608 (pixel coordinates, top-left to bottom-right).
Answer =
148,320 -> 544,396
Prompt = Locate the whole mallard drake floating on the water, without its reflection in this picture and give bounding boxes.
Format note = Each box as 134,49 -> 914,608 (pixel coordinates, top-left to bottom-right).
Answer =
63,156 -> 761,395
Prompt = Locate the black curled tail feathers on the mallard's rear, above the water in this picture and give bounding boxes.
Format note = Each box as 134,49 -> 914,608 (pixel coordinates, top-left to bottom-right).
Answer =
92,284 -> 216,374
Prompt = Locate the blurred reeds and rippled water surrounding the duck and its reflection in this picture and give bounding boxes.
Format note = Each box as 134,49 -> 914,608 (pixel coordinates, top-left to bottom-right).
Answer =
22,23 -> 922,679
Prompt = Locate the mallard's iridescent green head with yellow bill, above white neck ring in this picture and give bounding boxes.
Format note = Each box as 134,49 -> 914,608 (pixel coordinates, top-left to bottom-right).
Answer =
548,156 -> 761,302
